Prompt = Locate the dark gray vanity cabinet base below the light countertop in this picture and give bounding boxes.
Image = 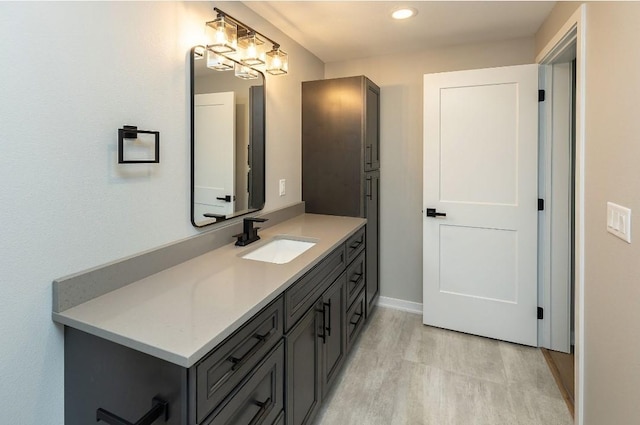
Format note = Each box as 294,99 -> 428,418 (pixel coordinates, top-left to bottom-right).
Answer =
65,227 -> 367,425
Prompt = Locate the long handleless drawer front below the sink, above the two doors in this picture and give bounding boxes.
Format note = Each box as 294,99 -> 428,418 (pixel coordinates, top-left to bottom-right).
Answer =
284,245 -> 347,331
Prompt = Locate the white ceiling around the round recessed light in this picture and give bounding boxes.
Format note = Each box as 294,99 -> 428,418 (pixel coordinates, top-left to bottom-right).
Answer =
244,1 -> 555,63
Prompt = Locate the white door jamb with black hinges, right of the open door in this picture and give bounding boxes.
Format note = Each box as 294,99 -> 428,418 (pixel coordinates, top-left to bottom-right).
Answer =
538,59 -> 575,353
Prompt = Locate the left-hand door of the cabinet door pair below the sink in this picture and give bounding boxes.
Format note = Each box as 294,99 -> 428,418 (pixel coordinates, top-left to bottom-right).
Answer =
286,300 -> 324,425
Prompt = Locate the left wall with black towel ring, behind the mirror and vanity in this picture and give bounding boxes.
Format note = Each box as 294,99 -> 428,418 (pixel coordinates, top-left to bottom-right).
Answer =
0,2 -> 324,425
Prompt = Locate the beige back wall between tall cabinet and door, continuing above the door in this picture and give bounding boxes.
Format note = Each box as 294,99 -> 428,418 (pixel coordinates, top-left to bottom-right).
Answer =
325,38 -> 535,303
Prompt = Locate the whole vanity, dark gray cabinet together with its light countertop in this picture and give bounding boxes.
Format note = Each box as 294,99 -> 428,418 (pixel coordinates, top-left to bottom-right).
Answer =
53,214 -> 366,425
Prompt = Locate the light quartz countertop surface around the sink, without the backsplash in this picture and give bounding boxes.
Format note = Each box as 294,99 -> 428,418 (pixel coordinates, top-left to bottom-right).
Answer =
53,214 -> 365,367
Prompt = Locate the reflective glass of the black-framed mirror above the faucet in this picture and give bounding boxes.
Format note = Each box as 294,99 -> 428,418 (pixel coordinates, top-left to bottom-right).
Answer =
191,46 -> 265,227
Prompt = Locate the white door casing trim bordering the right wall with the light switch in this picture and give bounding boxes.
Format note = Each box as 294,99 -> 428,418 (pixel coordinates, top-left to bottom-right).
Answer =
536,4 -> 586,425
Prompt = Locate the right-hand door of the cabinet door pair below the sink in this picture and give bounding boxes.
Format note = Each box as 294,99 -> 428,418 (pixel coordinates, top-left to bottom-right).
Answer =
321,273 -> 347,398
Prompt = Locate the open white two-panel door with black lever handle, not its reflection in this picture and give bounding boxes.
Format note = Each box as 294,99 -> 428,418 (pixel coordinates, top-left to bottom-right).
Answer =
423,65 -> 538,346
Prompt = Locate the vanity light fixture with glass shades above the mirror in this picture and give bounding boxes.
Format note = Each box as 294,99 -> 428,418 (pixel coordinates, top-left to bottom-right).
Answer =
206,7 -> 289,79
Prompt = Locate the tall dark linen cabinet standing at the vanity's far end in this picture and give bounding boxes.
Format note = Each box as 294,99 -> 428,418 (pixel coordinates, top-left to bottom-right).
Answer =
302,76 -> 380,315
